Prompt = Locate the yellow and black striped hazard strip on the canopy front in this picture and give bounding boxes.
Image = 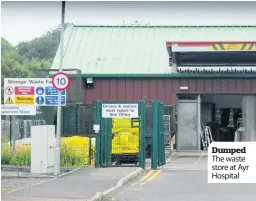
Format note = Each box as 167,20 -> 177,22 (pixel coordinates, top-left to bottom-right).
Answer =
210,43 -> 256,51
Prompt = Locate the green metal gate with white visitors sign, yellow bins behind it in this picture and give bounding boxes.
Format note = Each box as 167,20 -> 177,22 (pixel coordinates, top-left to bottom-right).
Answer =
95,101 -> 145,168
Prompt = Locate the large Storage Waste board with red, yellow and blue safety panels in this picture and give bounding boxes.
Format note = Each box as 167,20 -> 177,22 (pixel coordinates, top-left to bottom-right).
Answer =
4,78 -> 66,106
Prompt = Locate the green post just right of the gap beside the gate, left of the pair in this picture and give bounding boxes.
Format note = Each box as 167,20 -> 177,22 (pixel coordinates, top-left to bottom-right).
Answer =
151,101 -> 159,170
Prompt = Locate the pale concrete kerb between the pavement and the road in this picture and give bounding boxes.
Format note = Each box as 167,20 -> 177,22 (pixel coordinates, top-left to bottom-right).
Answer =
87,168 -> 144,201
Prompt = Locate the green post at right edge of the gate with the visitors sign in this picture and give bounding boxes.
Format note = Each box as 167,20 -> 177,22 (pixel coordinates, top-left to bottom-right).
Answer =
139,101 -> 146,169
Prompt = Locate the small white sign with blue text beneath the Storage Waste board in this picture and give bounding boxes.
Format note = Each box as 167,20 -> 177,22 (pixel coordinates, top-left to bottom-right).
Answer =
1,105 -> 36,115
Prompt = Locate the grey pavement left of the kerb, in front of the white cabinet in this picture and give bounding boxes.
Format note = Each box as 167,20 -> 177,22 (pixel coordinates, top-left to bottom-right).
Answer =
2,167 -> 136,201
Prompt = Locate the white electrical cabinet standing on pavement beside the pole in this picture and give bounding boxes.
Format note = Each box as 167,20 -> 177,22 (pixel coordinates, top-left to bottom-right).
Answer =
31,125 -> 55,174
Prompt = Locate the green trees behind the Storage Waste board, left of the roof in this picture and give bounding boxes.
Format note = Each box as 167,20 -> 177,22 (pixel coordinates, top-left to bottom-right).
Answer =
1,29 -> 60,104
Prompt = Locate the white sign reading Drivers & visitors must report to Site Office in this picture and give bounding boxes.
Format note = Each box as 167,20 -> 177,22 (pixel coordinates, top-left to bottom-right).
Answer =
102,103 -> 139,118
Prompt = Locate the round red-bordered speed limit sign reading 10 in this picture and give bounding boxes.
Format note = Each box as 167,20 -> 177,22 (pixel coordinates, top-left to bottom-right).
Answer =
52,72 -> 70,90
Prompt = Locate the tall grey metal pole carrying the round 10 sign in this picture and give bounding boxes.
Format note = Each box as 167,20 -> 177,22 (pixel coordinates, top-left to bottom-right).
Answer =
54,1 -> 65,176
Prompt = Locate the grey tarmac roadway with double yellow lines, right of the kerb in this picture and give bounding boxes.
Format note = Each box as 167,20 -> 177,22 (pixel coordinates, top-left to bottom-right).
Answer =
105,153 -> 256,201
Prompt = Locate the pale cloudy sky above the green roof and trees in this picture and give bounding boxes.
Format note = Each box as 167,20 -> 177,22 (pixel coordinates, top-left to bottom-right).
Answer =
1,1 -> 256,45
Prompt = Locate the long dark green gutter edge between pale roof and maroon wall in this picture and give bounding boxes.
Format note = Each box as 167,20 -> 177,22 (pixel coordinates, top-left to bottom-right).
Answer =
69,73 -> 256,79
